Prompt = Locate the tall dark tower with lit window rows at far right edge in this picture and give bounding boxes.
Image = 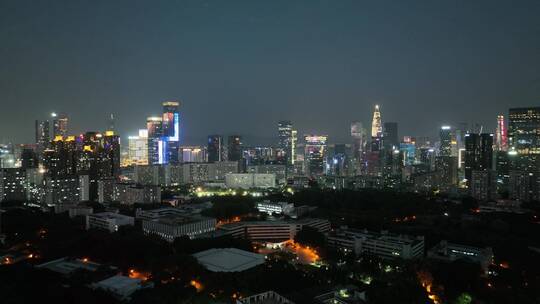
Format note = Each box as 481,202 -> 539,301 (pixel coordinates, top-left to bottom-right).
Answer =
508,107 -> 540,172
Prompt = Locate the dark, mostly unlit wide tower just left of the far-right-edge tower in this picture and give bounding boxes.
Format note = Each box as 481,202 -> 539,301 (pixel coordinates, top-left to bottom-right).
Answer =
465,133 -> 493,183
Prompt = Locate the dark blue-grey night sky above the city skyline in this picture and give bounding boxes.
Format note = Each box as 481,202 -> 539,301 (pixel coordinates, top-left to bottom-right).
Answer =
0,0 -> 540,144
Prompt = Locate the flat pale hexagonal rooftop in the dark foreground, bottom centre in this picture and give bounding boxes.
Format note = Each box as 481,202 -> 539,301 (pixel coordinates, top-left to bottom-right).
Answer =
193,248 -> 265,272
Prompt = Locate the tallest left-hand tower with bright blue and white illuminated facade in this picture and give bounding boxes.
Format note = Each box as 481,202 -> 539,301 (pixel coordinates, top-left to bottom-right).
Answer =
162,101 -> 180,164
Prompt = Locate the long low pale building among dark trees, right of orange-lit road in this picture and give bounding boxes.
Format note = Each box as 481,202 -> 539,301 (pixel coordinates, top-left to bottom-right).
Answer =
327,228 -> 424,259
